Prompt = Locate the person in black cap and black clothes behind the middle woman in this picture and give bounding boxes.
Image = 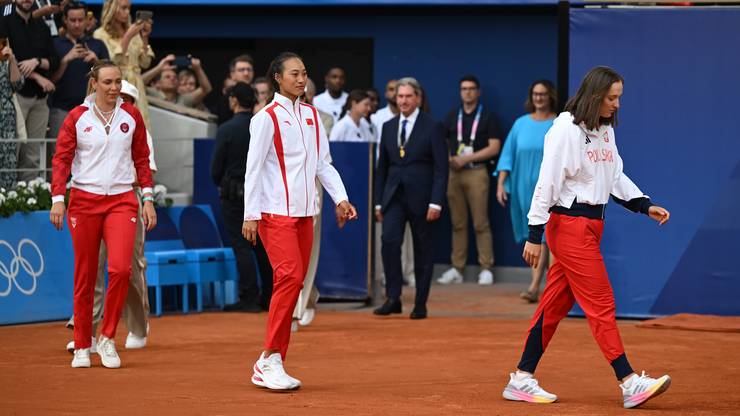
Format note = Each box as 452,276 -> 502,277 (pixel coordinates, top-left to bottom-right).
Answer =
211,82 -> 272,312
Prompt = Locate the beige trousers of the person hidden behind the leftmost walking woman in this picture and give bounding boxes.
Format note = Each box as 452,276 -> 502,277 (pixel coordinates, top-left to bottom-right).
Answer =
67,187 -> 149,337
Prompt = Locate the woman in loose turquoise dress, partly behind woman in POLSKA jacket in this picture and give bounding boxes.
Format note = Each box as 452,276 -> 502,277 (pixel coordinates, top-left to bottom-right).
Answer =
496,79 -> 558,303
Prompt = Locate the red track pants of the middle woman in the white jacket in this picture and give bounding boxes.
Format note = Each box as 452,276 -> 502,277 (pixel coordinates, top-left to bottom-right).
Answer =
258,213 -> 313,360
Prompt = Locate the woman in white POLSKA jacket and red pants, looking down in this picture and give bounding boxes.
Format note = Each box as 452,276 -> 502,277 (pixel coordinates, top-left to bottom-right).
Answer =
503,67 -> 671,408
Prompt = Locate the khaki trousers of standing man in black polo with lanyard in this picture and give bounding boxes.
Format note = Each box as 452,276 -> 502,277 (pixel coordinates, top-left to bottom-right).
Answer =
447,166 -> 493,273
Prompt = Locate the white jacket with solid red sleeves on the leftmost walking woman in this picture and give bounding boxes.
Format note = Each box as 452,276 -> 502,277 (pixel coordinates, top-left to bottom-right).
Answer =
51,94 -> 152,202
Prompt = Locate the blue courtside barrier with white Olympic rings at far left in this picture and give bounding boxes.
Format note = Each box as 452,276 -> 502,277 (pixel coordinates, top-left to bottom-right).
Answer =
0,211 -> 74,324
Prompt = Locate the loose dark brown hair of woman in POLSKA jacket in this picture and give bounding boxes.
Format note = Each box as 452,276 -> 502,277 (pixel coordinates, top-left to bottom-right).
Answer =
565,66 -> 624,130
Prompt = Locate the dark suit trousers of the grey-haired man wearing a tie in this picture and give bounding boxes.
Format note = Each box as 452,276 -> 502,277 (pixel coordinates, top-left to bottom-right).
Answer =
381,189 -> 434,306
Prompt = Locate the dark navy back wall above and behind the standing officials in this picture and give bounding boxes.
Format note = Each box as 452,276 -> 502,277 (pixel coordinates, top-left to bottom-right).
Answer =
162,7 -> 557,266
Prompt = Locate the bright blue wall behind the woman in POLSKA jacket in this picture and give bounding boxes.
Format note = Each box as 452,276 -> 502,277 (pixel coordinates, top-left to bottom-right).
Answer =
570,7 -> 740,316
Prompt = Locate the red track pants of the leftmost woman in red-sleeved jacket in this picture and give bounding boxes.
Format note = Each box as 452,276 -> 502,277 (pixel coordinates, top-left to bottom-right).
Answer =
67,188 -> 140,349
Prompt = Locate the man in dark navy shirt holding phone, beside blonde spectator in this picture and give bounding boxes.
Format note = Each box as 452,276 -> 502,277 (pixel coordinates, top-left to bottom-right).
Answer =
48,2 -> 108,138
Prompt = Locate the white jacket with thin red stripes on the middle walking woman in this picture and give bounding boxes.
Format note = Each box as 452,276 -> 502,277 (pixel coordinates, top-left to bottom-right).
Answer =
244,93 -> 348,221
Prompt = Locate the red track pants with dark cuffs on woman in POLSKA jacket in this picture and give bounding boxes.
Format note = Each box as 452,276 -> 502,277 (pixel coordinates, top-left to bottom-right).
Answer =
518,213 -> 632,379
